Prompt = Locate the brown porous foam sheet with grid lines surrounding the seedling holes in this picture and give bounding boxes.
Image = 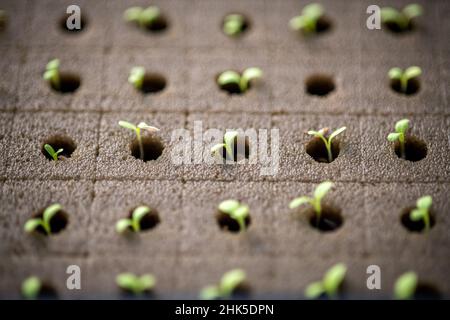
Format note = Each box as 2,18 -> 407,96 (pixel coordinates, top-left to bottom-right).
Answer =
0,0 -> 450,299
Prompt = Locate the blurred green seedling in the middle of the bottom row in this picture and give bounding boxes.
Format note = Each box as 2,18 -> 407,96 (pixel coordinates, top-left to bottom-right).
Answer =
200,269 -> 247,300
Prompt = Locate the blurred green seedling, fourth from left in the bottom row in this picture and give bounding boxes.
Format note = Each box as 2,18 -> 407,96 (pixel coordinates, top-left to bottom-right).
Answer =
304,263 -> 347,299
